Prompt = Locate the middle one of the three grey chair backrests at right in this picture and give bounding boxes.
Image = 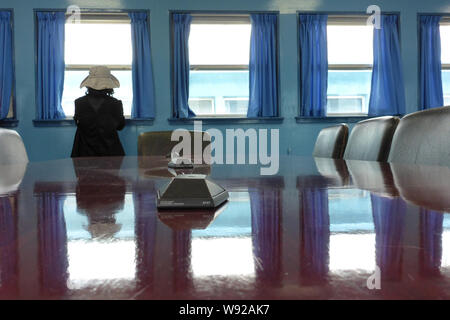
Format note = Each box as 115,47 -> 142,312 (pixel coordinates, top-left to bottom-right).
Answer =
344,116 -> 400,162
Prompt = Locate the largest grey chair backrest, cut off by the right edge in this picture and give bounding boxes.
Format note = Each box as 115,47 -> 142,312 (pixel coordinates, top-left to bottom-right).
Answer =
388,107 -> 450,166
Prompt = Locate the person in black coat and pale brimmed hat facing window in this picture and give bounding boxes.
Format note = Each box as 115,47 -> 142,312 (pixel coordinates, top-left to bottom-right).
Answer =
71,66 -> 125,158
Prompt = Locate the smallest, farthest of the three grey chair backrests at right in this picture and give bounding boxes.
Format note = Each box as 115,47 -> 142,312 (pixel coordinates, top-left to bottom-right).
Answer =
313,123 -> 348,159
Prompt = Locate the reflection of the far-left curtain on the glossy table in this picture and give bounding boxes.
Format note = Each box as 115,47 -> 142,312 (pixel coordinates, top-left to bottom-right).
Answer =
0,197 -> 17,291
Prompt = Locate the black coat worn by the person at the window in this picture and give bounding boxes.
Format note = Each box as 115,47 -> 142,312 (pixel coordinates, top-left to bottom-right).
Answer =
71,95 -> 125,158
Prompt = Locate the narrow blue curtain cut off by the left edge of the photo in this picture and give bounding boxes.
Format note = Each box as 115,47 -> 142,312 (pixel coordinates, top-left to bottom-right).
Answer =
0,11 -> 13,120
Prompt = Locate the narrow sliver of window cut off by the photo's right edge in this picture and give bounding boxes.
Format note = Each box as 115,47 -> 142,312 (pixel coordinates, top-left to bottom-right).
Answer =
439,22 -> 450,106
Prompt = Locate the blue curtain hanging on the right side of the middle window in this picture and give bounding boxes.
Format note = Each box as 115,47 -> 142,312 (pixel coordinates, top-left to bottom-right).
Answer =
247,14 -> 278,117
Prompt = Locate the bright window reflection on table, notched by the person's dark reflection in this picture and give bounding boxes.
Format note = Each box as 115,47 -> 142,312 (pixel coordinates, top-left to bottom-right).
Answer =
64,194 -> 136,290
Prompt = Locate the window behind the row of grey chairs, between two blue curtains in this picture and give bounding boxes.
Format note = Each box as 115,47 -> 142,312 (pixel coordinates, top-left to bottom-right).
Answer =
327,16 -> 373,116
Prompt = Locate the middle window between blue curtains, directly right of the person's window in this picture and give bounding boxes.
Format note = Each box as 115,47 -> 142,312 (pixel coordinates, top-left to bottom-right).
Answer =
189,14 -> 251,116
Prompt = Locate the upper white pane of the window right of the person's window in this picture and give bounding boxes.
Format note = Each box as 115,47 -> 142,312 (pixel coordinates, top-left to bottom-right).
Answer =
189,24 -> 251,65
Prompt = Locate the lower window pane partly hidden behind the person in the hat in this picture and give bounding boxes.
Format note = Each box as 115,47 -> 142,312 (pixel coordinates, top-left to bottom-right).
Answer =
62,70 -> 133,117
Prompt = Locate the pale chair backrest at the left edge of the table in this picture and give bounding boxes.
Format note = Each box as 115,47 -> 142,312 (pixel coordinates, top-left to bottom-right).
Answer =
0,128 -> 28,165
